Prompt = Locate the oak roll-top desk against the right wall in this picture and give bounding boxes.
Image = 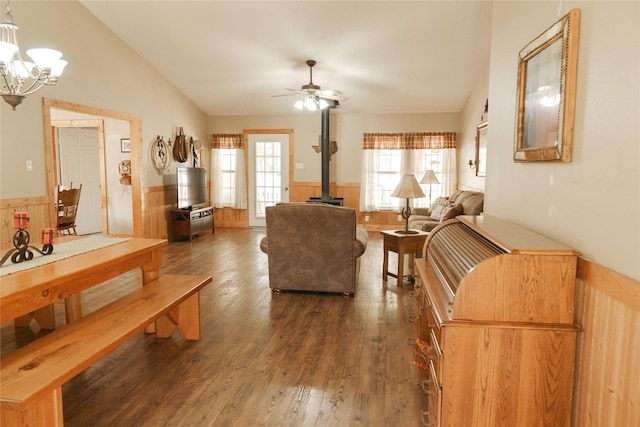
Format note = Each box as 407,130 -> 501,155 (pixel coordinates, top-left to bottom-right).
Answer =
414,217 -> 579,427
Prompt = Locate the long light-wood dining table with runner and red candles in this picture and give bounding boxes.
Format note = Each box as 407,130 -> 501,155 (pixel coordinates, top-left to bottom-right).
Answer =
0,239 -> 167,329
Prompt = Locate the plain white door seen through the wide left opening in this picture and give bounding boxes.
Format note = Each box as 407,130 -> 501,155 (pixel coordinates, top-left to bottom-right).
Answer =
57,127 -> 102,234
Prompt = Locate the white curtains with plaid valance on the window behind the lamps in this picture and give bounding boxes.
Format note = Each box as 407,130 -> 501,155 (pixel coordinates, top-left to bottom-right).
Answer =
360,132 -> 457,212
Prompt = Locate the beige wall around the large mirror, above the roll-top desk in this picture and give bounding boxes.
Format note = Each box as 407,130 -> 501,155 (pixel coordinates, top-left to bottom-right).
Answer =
485,1 -> 640,279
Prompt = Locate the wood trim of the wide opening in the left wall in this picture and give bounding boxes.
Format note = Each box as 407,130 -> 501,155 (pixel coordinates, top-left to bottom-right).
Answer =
42,98 -> 145,238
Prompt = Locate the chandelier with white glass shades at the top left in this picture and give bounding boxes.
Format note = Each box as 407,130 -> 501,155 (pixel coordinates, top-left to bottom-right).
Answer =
0,2 -> 67,110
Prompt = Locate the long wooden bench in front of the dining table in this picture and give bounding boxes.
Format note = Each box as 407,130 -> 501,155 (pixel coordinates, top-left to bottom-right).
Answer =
0,275 -> 211,426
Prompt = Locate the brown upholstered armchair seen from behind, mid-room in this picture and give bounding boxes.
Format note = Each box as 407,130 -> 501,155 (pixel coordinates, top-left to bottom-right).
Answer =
260,203 -> 369,296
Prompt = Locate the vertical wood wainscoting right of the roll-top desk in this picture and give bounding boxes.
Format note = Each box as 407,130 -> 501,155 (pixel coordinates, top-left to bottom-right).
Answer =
573,259 -> 640,427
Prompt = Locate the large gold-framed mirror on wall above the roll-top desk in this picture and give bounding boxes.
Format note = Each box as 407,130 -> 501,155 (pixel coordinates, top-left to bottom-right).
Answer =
513,9 -> 580,162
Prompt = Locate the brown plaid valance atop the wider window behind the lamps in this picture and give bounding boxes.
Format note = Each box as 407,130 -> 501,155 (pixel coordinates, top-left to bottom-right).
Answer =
362,132 -> 456,150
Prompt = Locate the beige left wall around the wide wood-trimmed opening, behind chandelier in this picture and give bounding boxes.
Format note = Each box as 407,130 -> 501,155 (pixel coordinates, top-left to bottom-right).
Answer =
0,1 -> 207,199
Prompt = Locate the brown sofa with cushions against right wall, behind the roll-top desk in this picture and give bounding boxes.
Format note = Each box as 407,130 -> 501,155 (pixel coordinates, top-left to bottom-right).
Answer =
409,190 -> 484,231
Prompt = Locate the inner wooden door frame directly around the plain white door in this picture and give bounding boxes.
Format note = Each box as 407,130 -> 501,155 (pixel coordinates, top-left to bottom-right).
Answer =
51,119 -> 109,236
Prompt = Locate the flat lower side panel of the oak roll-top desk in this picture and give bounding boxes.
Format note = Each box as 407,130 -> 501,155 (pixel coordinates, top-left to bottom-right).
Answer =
441,325 -> 576,427
